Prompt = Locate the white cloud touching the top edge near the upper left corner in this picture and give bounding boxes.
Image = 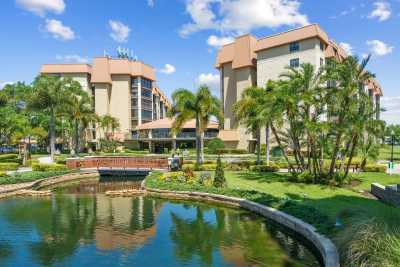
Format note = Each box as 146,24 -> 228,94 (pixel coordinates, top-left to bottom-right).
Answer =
16,0 -> 65,17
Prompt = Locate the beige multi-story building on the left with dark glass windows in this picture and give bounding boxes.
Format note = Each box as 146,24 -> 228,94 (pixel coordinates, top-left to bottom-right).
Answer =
40,57 -> 171,141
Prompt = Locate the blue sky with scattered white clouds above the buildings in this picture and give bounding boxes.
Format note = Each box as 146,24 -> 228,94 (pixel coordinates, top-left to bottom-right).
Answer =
0,0 -> 400,124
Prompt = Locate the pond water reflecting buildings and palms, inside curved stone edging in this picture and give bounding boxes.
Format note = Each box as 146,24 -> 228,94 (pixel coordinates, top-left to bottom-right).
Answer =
0,179 -> 320,267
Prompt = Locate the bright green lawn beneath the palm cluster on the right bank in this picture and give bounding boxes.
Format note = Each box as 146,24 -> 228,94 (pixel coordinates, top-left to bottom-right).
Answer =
226,172 -> 400,224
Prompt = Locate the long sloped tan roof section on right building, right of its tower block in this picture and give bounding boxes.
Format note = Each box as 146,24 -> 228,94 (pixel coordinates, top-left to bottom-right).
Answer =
255,24 -> 329,52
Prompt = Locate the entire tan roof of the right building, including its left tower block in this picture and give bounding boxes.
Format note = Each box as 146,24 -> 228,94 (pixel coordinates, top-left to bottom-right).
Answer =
215,24 -> 329,69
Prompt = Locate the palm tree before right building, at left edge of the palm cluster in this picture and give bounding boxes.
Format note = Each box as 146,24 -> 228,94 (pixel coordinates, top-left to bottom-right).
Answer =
233,87 -> 266,164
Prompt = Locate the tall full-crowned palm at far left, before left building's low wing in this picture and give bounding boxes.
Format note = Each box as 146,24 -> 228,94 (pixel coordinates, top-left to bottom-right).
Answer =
28,75 -> 76,161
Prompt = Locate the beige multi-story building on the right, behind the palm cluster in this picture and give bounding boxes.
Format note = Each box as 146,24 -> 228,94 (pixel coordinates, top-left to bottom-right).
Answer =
216,24 -> 382,149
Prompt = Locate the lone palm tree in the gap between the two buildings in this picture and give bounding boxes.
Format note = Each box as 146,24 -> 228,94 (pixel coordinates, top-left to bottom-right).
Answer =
168,86 -> 223,164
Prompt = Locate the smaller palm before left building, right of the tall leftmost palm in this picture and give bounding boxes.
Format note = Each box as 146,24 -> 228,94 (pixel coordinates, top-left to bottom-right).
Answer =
67,90 -> 97,155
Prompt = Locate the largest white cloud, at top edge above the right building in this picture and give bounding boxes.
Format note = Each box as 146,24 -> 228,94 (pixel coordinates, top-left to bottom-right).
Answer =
180,0 -> 308,37
